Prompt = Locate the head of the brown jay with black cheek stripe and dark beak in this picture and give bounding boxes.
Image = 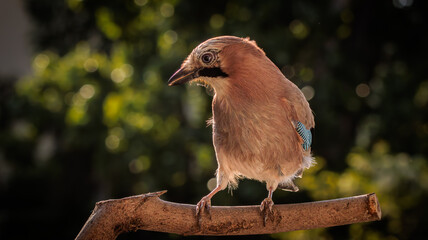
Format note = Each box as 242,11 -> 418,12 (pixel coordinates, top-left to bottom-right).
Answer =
168,36 -> 275,93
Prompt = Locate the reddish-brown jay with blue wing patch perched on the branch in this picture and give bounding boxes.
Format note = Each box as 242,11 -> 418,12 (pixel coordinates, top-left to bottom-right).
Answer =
168,36 -> 315,222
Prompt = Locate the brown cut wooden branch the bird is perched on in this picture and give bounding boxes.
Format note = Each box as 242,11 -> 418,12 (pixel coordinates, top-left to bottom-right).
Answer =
76,191 -> 381,240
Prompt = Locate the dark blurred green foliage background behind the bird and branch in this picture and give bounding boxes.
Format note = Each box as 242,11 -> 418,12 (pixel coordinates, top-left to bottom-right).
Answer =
0,0 -> 428,239
